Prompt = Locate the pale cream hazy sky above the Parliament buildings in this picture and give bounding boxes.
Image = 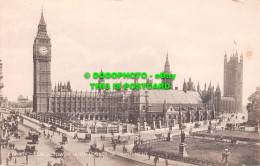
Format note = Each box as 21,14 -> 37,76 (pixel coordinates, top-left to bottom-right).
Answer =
0,0 -> 260,104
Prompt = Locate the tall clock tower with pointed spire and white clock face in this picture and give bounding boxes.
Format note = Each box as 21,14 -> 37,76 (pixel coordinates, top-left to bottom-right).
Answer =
33,12 -> 51,112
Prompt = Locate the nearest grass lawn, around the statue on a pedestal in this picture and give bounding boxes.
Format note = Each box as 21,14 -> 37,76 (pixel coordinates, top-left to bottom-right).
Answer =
143,138 -> 260,165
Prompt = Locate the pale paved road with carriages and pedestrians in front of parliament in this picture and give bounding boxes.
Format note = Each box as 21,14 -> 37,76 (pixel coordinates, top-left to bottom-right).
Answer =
2,111 -> 247,166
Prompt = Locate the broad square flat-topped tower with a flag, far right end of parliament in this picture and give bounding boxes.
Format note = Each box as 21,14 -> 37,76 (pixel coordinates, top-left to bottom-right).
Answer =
224,52 -> 243,112
